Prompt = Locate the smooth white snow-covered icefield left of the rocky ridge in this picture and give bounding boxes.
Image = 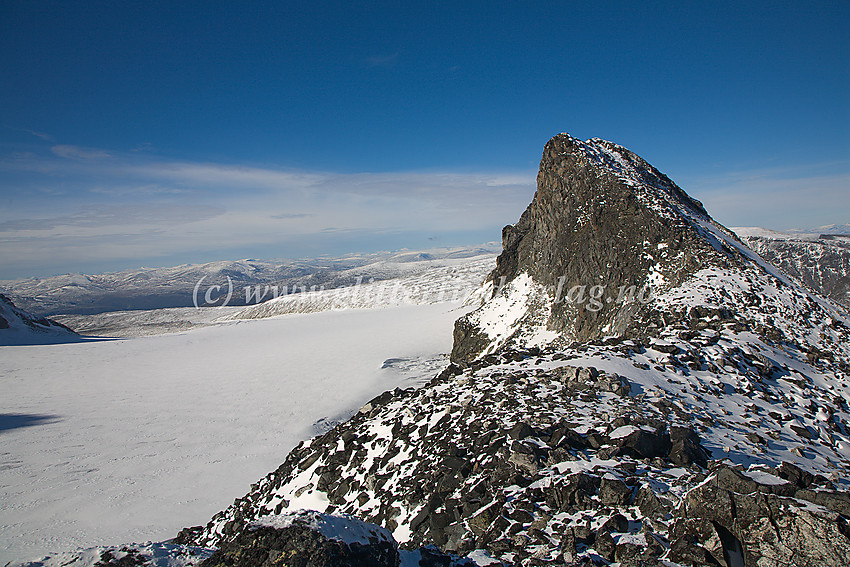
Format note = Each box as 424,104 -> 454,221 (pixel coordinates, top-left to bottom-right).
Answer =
0,303 -> 462,565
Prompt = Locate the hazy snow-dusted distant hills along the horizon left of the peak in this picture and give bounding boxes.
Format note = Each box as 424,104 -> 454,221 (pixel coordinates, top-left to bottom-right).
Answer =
0,247 -> 498,315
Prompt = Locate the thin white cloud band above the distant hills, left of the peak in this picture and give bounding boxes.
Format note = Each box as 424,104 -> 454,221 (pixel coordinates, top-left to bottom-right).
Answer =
0,146 -> 534,279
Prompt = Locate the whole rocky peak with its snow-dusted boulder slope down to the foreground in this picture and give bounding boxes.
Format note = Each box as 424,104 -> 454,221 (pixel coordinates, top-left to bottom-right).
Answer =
156,134 -> 850,567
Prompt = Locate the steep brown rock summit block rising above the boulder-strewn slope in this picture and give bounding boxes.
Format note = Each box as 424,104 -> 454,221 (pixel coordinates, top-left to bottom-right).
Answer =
452,134 -> 748,362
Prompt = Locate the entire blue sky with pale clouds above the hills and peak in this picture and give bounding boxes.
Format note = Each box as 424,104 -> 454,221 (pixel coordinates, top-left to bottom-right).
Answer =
0,0 -> 850,278
